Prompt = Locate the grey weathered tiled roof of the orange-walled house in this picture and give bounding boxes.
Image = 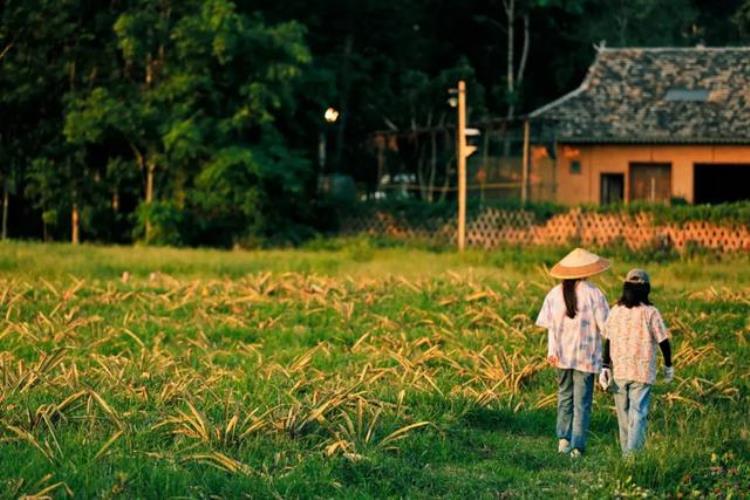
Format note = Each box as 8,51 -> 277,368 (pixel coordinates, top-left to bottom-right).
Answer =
529,47 -> 750,144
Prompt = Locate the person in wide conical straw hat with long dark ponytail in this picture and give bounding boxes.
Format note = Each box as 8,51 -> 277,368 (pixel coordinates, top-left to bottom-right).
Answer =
536,248 -> 610,458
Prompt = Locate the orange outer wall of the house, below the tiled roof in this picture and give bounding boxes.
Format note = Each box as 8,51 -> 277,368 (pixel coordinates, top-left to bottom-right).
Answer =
554,145 -> 750,205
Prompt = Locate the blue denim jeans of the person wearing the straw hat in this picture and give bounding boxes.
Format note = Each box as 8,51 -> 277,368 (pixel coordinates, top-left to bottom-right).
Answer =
557,369 -> 594,451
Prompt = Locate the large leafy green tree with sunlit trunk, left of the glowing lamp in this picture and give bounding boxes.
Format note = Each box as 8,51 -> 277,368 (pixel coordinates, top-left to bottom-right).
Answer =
65,0 -> 309,241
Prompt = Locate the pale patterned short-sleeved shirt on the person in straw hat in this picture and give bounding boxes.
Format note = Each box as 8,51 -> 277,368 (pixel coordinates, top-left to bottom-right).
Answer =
536,281 -> 609,373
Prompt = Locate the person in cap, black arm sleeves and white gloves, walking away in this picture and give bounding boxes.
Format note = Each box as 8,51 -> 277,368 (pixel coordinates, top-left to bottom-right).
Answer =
599,269 -> 674,455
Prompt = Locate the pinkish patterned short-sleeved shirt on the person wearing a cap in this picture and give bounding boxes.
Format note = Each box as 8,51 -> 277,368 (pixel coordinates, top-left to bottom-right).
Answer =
603,305 -> 669,384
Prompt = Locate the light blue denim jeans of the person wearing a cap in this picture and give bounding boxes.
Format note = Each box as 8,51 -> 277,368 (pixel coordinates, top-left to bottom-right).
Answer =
612,380 -> 651,455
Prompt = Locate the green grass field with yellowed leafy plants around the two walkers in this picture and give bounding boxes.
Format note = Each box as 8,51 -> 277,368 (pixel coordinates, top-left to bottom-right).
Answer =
0,240 -> 750,498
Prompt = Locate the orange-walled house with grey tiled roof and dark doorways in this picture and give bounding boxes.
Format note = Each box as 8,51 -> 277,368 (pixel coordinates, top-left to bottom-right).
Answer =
528,47 -> 750,205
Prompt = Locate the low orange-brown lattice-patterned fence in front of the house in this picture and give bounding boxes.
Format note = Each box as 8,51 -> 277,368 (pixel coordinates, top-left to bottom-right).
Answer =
342,208 -> 750,252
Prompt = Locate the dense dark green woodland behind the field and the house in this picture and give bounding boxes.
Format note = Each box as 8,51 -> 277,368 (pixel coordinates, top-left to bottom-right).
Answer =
0,0 -> 750,245
